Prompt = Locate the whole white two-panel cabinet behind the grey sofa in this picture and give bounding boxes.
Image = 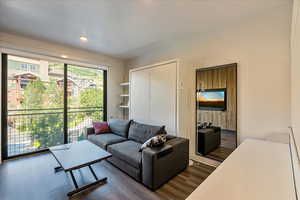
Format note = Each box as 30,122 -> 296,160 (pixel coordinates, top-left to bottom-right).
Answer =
130,62 -> 177,135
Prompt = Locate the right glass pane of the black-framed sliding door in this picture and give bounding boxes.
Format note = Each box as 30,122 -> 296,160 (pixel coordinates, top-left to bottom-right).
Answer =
67,65 -> 104,142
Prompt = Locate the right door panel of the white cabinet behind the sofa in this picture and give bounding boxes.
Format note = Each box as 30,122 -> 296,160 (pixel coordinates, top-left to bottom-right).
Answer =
149,62 -> 177,135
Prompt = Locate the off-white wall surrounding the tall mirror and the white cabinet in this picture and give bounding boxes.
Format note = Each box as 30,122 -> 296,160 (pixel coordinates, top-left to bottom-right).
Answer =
126,5 -> 291,165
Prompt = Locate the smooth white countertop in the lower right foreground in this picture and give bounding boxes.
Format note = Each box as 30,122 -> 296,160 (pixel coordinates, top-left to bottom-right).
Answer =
187,139 -> 296,200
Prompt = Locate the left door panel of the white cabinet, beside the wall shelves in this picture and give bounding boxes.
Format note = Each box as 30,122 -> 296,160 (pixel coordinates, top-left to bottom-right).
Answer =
130,70 -> 150,123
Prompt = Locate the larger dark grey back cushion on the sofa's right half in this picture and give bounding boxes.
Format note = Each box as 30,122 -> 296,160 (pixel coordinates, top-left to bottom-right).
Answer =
128,121 -> 166,143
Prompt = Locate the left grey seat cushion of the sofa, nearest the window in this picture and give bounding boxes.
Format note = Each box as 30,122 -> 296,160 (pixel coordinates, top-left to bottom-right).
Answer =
88,133 -> 127,150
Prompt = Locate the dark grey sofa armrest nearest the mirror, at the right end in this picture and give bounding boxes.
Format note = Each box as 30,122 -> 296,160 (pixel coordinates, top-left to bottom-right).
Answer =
142,137 -> 189,190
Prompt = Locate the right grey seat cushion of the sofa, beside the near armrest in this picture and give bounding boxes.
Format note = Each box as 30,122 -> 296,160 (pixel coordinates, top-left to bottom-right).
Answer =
107,140 -> 142,169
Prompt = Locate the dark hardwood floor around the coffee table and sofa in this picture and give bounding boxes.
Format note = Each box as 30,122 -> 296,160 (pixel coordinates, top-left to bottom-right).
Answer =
0,153 -> 215,200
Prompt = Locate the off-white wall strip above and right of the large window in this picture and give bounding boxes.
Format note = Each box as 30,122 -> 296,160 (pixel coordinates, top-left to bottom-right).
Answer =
0,32 -> 124,162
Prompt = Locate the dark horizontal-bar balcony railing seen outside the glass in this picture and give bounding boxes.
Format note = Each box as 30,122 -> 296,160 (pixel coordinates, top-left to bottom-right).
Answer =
7,107 -> 103,157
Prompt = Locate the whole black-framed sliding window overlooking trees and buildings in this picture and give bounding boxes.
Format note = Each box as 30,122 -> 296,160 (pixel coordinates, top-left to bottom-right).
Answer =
2,54 -> 106,158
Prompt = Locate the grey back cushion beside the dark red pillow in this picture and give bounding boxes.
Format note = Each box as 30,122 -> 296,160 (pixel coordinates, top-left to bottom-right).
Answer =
108,119 -> 131,138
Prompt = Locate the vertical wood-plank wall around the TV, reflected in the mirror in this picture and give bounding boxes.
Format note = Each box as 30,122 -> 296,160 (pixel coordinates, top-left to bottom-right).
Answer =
196,63 -> 237,131
